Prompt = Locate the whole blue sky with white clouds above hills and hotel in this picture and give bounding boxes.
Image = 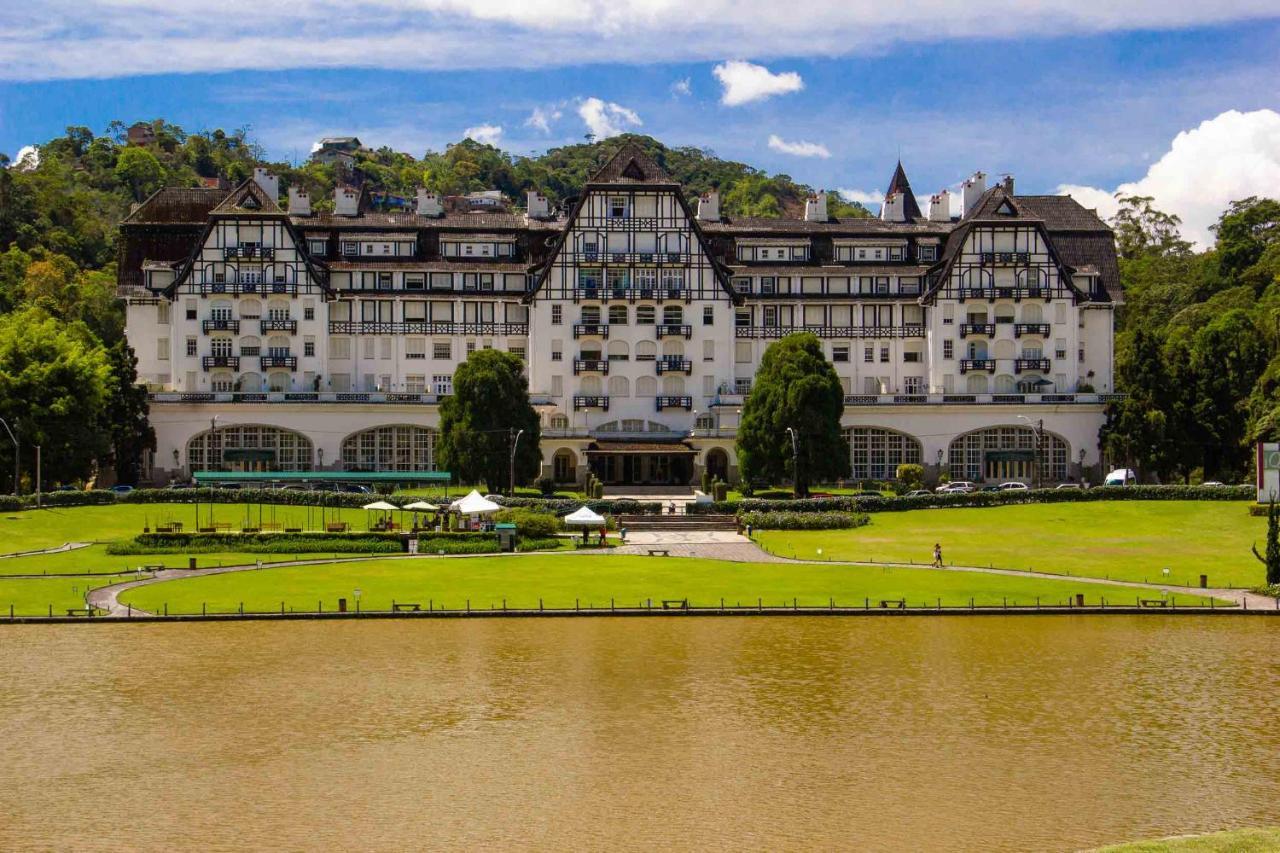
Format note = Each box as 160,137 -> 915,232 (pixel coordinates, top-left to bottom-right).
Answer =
0,0 -> 1280,240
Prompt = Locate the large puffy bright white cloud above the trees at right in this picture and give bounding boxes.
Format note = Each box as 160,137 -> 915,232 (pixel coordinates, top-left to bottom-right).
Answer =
1057,110 -> 1280,248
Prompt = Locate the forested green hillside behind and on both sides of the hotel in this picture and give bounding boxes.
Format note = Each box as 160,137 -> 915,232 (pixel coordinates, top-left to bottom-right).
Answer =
0,120 -> 1280,484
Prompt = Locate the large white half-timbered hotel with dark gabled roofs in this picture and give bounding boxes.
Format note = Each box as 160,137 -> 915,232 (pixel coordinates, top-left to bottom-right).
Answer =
119,145 -> 1120,485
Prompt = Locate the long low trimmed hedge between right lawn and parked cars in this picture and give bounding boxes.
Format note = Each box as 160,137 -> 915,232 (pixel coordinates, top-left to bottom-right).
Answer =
686,485 -> 1257,515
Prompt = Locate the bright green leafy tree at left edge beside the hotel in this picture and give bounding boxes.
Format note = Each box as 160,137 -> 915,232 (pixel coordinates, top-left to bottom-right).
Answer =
0,309 -> 111,482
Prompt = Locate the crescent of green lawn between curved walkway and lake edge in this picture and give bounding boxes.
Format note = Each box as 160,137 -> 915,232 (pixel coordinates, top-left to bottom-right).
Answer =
122,555 -> 1218,613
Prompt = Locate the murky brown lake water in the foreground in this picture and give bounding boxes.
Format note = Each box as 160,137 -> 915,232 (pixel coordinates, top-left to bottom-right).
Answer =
0,616 -> 1280,850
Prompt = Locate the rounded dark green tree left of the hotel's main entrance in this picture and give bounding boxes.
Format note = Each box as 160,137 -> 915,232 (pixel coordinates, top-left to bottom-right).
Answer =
438,350 -> 543,492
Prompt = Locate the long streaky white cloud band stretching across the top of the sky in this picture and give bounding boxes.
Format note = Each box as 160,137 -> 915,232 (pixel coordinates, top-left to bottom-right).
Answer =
0,0 -> 1275,79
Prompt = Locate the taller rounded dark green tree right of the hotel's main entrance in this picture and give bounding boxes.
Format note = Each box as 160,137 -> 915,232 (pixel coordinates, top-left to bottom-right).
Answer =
737,334 -> 849,496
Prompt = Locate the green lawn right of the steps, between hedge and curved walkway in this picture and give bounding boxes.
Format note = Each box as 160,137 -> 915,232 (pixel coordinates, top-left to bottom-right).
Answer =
756,501 -> 1266,587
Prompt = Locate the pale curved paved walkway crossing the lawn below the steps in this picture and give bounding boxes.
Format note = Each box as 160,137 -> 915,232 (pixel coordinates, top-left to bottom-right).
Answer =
87,530 -> 1277,617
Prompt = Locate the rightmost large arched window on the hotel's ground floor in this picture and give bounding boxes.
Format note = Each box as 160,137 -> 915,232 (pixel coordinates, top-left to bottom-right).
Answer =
948,427 -> 1071,483
